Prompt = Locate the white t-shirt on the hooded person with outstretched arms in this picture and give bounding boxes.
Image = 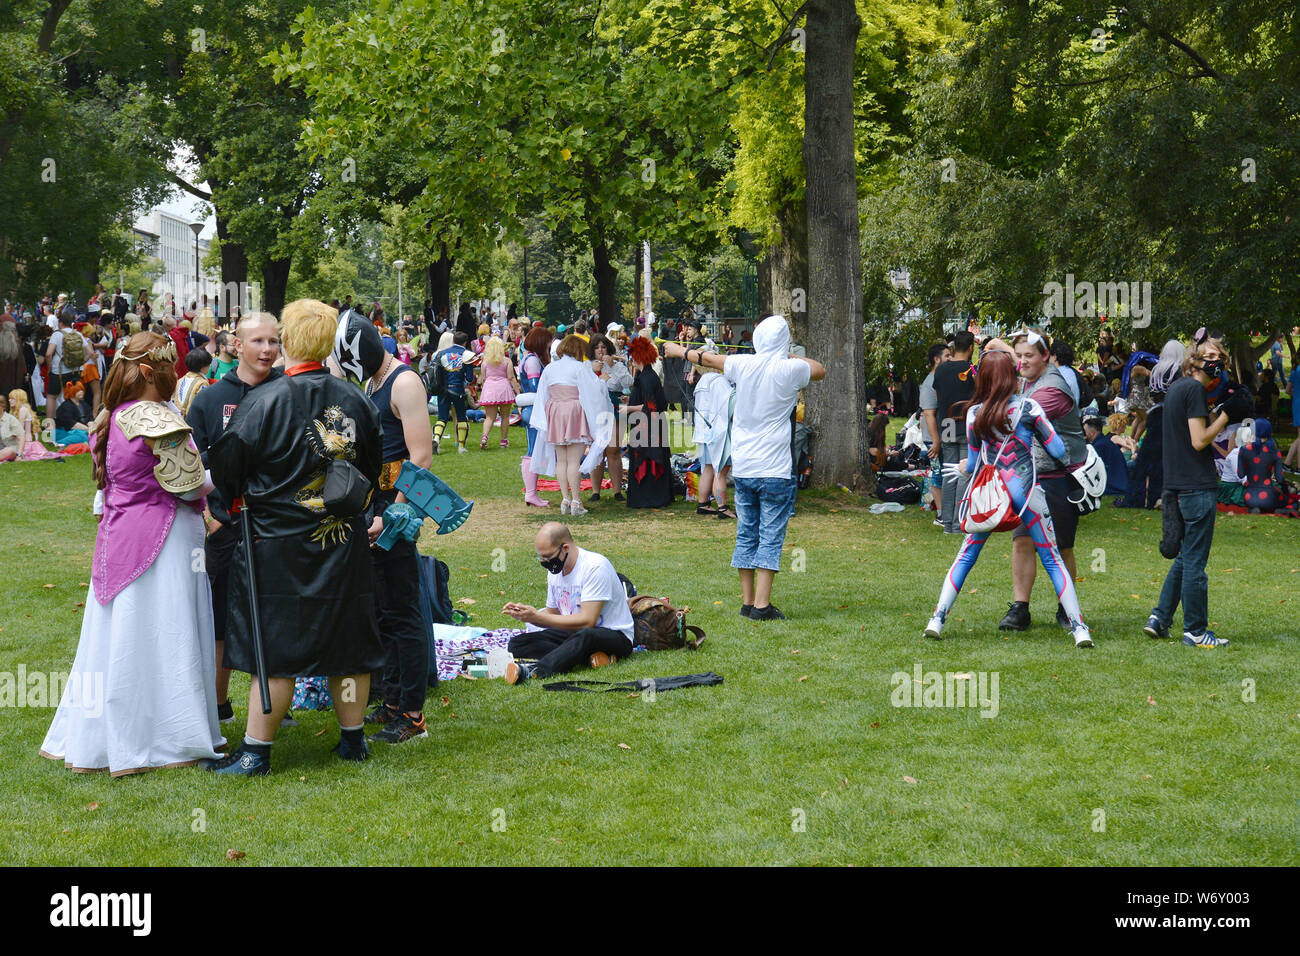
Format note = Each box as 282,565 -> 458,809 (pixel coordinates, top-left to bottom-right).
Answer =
723,355 -> 813,479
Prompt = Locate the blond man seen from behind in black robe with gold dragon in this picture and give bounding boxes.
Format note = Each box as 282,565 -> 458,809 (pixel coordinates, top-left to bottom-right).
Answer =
208,299 -> 384,775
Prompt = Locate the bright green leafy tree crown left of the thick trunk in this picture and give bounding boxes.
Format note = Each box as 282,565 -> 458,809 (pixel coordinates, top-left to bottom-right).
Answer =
274,0 -> 723,332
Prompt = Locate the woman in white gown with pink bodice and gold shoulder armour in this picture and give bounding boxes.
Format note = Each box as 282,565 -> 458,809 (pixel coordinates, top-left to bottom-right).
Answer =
40,332 -> 225,777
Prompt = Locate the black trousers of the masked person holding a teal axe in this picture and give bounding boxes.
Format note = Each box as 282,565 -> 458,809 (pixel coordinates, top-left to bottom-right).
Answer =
371,541 -> 429,714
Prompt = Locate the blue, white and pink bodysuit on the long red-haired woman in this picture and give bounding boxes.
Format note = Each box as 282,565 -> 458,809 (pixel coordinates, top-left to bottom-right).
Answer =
926,395 -> 1091,646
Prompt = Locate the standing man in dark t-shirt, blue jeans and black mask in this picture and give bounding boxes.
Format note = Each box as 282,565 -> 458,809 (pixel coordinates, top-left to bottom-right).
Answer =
1143,342 -> 1253,648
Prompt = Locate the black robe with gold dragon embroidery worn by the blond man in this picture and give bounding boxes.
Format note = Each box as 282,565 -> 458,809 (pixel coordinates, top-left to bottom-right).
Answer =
208,369 -> 384,678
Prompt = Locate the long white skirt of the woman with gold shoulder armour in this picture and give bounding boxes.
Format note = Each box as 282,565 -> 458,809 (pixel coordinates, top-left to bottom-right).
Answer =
40,505 -> 225,777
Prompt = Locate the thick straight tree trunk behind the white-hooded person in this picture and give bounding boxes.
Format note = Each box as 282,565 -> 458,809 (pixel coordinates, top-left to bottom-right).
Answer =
803,0 -> 872,492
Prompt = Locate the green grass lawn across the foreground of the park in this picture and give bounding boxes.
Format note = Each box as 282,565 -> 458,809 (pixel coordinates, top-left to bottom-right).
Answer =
0,431 -> 1300,866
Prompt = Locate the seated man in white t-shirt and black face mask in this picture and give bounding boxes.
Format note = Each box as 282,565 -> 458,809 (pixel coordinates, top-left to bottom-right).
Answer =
502,522 -> 632,684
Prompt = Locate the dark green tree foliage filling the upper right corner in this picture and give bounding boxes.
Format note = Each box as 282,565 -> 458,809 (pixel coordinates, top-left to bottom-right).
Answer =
866,0 -> 1300,381
